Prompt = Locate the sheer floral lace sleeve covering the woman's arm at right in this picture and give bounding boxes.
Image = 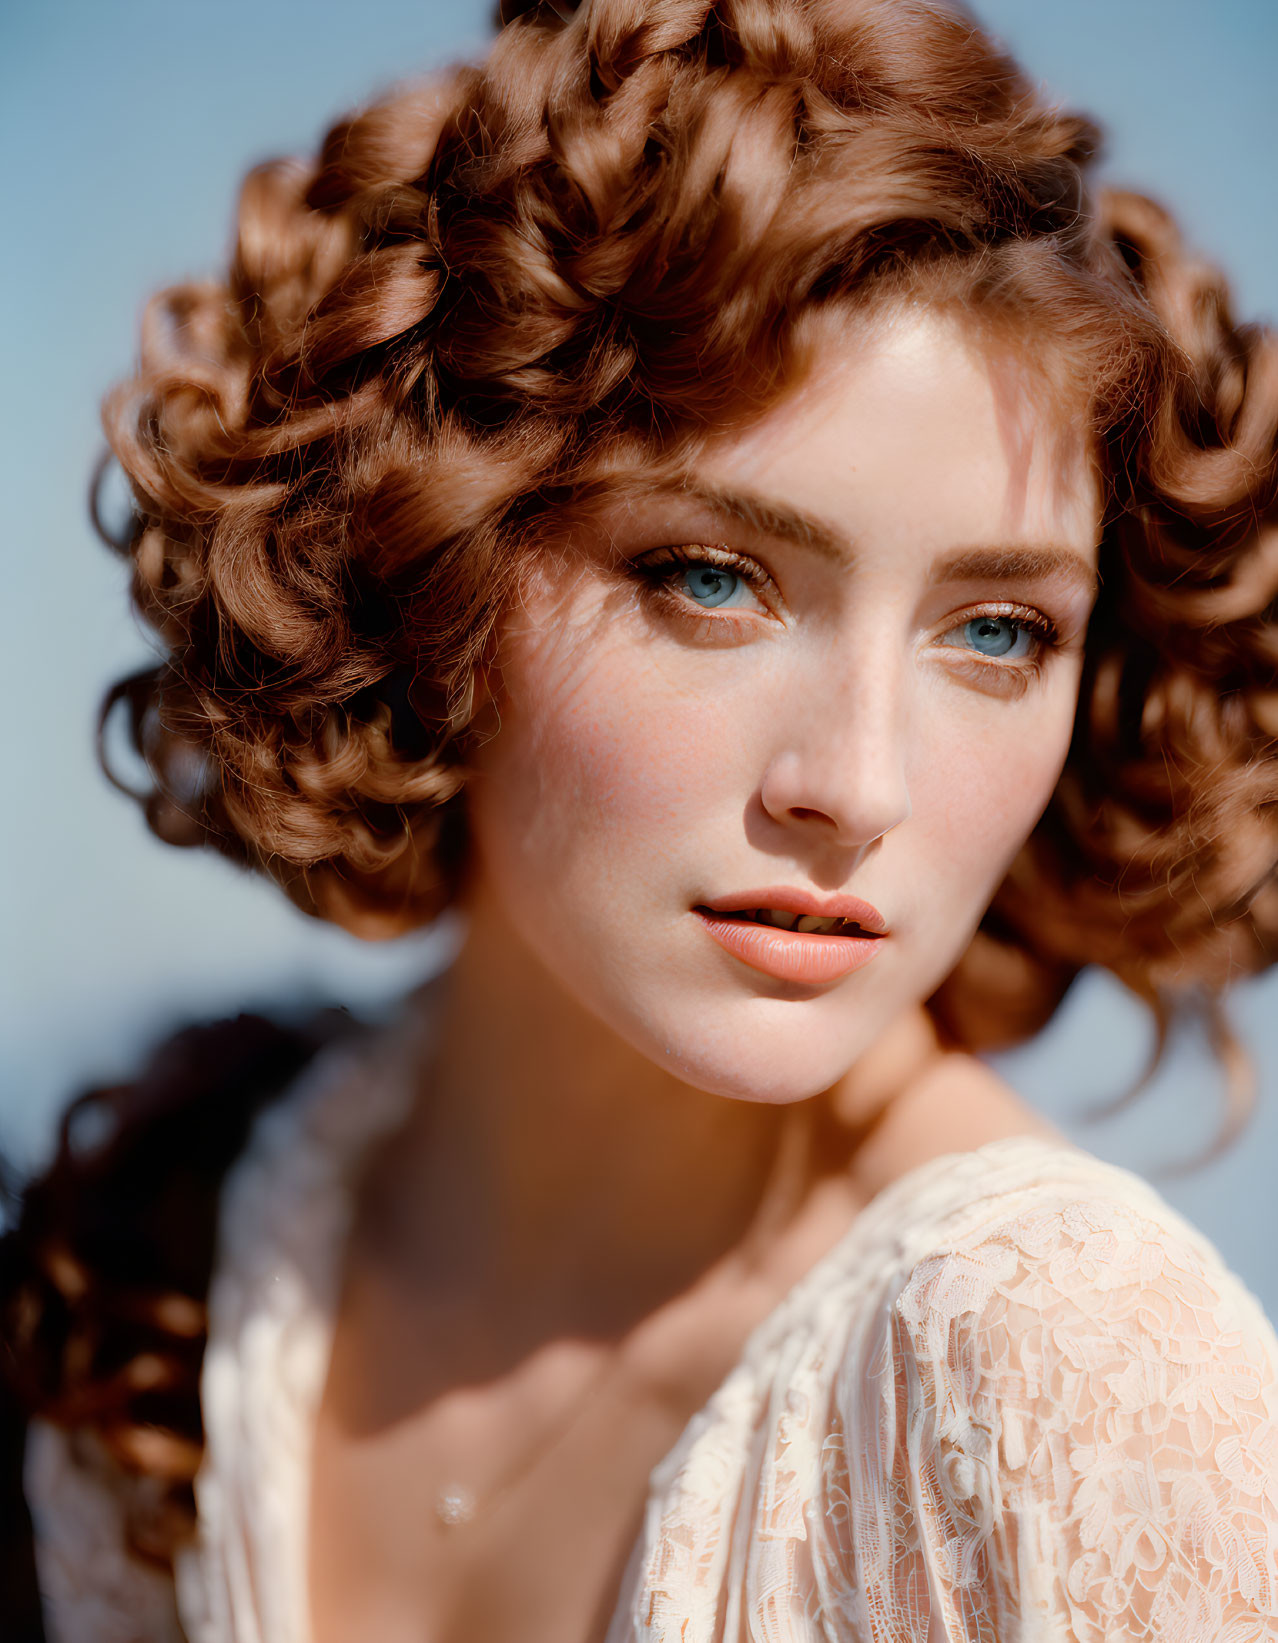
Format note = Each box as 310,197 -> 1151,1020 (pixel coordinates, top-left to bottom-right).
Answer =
857,1194 -> 1278,1643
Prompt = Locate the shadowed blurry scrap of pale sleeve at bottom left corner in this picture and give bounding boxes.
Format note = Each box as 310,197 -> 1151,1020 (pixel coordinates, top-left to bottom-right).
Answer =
23,1421 -> 182,1643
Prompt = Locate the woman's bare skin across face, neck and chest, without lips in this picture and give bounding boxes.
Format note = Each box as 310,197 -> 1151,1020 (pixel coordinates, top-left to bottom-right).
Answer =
310,311 -> 1099,1643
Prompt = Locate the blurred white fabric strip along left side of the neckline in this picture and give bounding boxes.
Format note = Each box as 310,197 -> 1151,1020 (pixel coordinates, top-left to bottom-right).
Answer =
177,1037 -> 414,1638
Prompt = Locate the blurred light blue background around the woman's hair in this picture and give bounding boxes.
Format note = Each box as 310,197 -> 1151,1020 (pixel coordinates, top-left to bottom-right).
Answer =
0,0 -> 1278,1316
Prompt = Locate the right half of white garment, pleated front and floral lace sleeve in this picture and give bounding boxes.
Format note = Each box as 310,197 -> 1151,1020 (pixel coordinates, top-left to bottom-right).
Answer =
608,1139 -> 1278,1643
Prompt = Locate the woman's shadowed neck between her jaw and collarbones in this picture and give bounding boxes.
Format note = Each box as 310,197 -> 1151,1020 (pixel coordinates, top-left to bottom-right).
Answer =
372,899 -> 935,1323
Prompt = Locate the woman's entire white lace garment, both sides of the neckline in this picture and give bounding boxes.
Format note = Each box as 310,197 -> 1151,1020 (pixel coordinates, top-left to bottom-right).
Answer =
26,1050 -> 1278,1643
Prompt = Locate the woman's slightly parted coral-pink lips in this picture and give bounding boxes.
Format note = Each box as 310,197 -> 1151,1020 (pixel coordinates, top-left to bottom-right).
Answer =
693,886 -> 889,986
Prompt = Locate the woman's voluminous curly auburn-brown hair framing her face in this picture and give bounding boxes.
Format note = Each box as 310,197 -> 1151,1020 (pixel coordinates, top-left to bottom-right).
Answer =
13,0 -> 1278,1583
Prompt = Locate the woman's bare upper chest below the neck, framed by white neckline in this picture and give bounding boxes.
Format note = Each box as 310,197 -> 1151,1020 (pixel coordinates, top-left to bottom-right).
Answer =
307,1260 -> 785,1643
